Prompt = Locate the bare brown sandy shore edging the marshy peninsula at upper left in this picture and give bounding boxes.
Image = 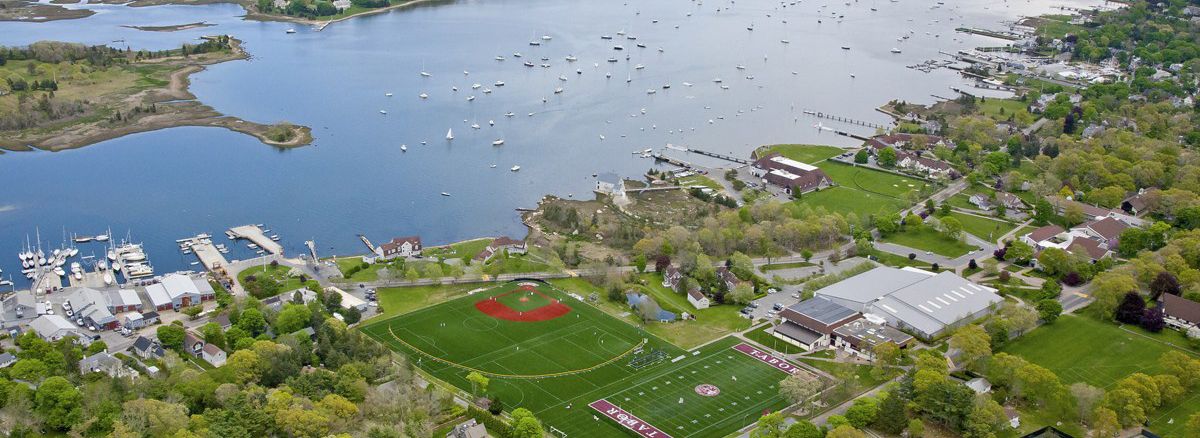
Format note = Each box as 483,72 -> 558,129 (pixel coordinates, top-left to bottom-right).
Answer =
0,38 -> 313,152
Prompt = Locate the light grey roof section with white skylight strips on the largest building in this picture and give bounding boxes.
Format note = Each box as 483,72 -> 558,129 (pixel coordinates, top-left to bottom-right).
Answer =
872,271 -> 1003,335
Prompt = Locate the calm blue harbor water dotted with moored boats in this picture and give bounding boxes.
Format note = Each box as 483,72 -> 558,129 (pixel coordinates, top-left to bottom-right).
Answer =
0,0 -> 1104,283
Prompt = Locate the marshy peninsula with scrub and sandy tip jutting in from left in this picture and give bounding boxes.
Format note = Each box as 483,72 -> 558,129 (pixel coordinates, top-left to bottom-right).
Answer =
0,36 -> 312,151
